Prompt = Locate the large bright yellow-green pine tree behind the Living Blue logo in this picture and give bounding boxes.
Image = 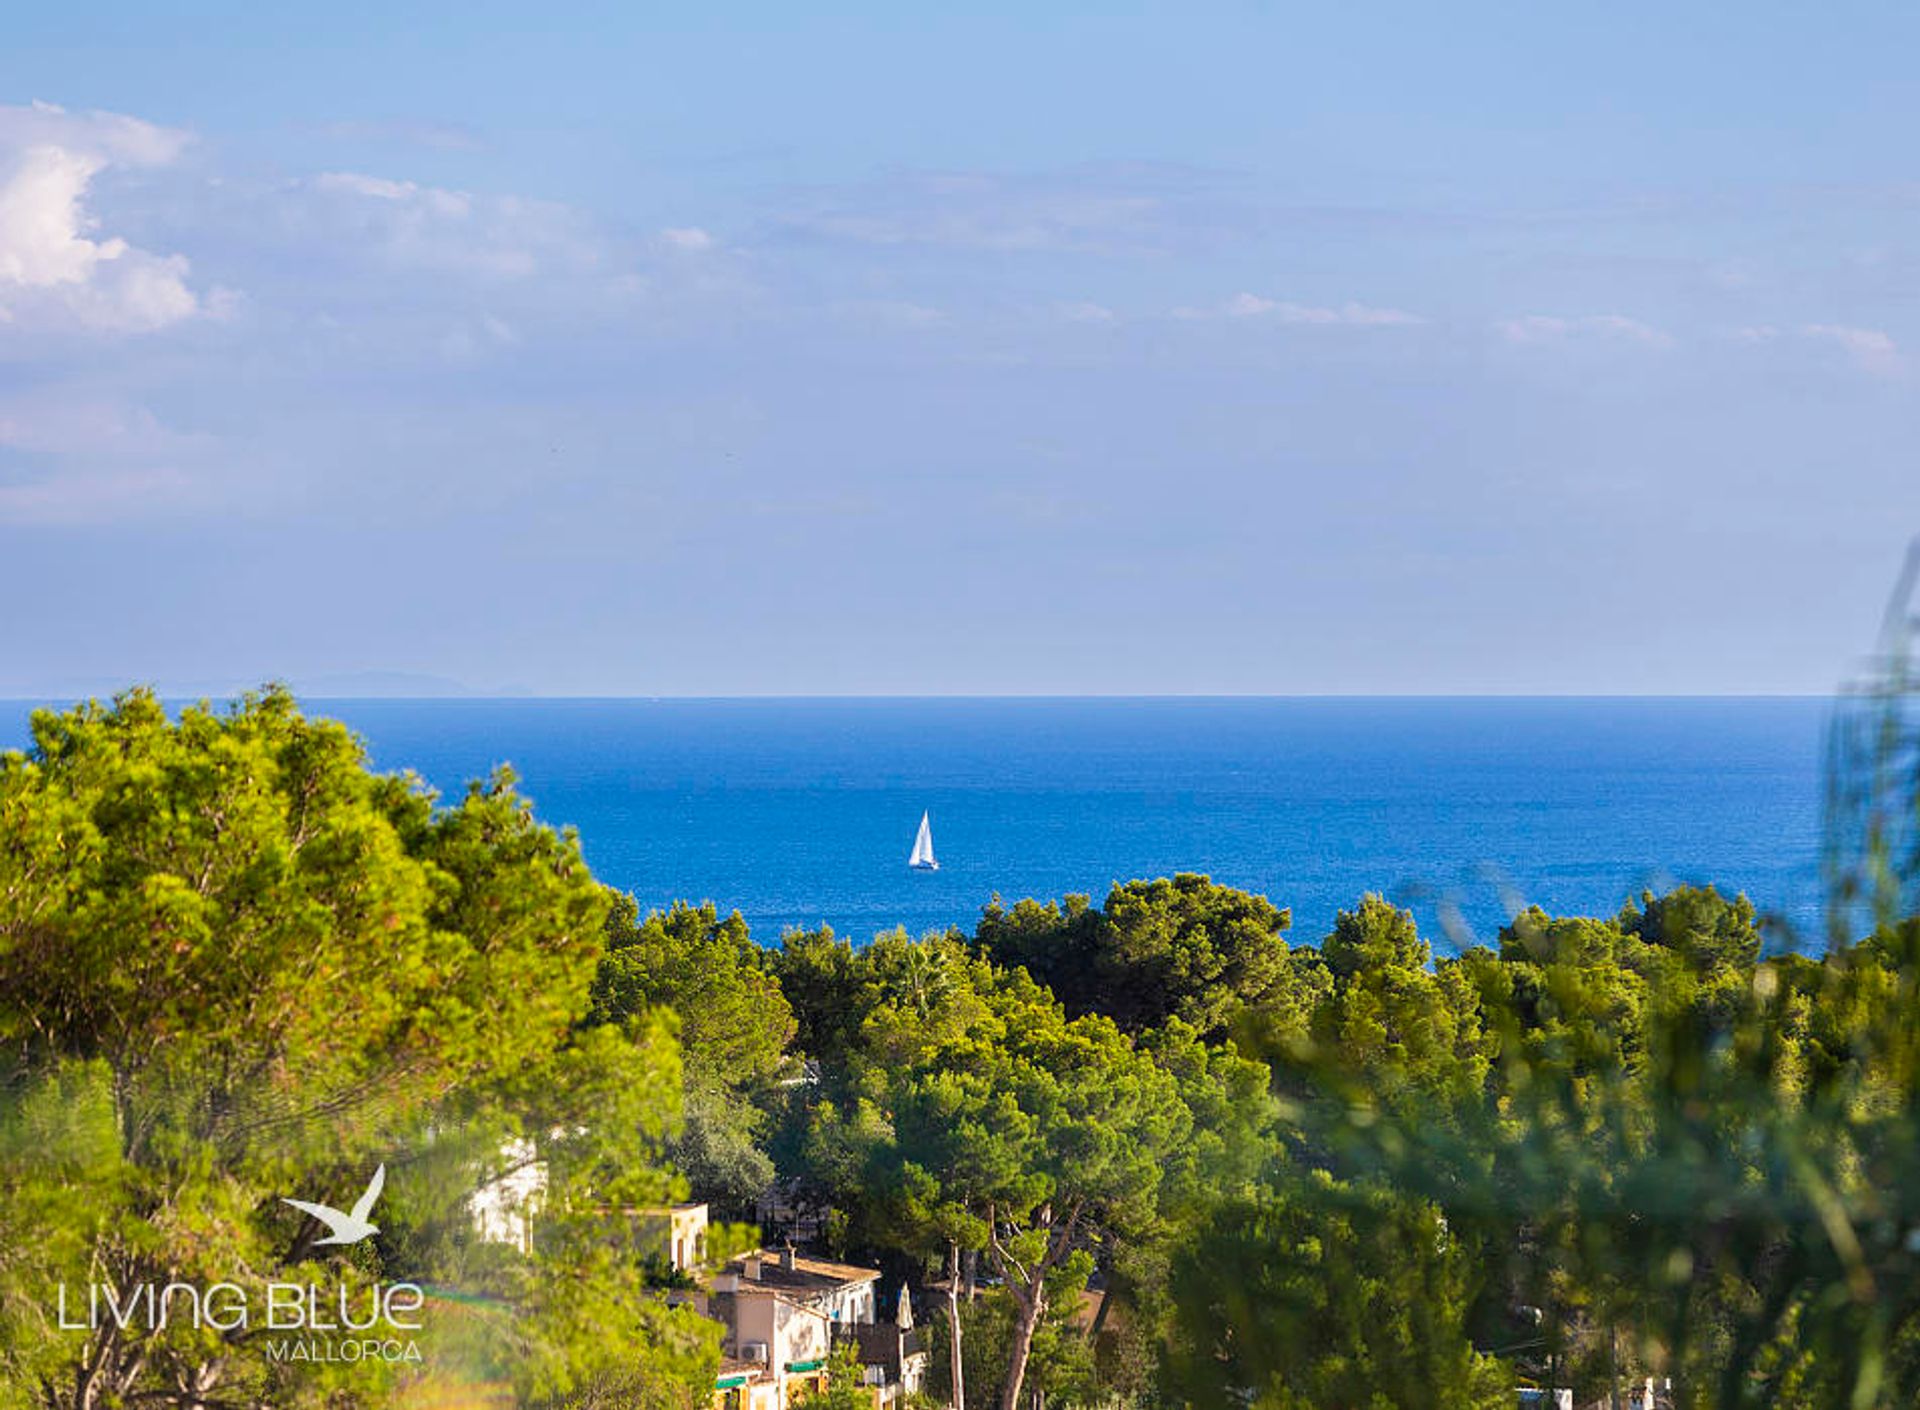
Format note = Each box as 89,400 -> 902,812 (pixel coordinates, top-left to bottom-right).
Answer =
0,690 -> 716,1408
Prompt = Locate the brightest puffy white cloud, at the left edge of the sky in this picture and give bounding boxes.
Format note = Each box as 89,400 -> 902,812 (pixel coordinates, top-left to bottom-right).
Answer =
0,104 -> 204,332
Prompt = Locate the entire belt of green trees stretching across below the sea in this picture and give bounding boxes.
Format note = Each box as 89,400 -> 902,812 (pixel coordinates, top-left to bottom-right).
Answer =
22,692 -> 1920,1410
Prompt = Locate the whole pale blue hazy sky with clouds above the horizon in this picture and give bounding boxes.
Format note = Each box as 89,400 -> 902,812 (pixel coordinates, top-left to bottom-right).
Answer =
0,0 -> 1920,695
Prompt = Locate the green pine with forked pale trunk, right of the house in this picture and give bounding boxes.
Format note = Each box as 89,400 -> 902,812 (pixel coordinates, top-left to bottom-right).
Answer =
787,936 -> 1192,1404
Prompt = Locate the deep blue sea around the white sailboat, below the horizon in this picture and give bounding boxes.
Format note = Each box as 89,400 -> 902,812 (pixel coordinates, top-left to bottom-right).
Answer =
0,697 -> 1828,951
